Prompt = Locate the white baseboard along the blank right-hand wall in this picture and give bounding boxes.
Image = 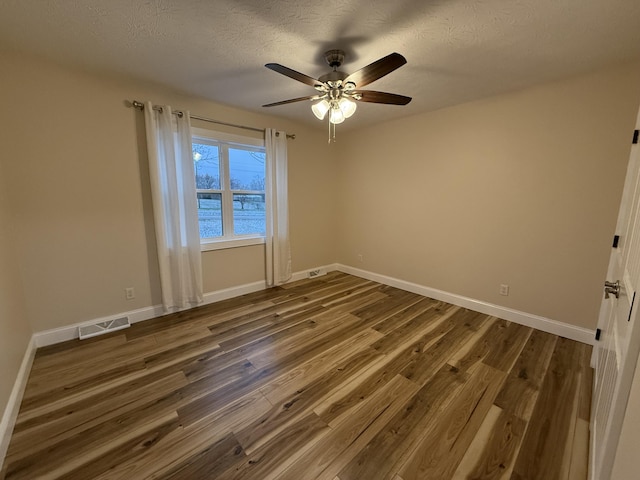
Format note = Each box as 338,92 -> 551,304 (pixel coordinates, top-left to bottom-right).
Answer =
335,264 -> 595,345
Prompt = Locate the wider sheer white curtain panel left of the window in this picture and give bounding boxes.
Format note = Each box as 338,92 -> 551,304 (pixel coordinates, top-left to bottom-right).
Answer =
144,102 -> 202,312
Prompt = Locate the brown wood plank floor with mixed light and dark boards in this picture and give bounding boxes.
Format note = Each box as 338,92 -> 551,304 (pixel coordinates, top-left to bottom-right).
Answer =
0,272 -> 592,480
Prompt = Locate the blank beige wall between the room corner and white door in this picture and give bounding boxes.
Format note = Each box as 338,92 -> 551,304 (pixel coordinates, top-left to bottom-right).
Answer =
338,60 -> 640,328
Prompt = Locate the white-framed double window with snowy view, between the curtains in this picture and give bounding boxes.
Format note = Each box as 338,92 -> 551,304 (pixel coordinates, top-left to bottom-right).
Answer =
192,128 -> 266,250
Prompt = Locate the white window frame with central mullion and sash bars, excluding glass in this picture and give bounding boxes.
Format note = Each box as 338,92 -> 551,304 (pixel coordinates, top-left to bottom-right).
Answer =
191,127 -> 268,252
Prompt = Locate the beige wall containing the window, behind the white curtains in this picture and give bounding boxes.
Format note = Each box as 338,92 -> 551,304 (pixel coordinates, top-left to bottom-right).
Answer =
0,49 -> 336,331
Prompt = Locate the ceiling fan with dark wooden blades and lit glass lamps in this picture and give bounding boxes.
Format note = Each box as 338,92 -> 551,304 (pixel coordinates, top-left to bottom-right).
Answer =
263,50 -> 411,131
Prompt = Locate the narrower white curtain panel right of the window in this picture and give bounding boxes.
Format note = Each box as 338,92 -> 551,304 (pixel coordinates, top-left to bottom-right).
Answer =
265,128 -> 291,287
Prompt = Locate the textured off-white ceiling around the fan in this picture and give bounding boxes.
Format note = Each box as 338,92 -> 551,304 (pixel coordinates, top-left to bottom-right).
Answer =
0,0 -> 640,129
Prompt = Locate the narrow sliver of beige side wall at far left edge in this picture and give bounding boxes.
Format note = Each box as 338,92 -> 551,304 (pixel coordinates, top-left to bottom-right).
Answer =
0,149 -> 31,416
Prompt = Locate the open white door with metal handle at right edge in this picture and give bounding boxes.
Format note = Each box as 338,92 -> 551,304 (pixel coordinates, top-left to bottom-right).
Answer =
590,113 -> 640,480
